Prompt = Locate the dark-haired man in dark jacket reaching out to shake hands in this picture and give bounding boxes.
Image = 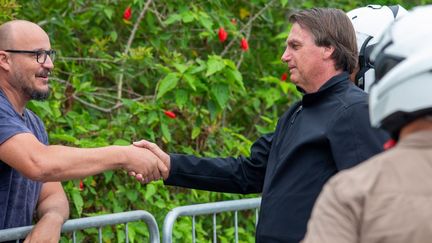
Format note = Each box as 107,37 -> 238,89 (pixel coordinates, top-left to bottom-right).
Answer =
135,9 -> 387,243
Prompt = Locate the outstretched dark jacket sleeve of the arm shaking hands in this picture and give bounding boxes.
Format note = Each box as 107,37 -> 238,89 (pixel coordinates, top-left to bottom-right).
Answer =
165,134 -> 273,194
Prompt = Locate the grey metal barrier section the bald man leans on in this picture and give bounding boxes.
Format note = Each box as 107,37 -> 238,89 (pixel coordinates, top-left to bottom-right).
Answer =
0,210 -> 160,243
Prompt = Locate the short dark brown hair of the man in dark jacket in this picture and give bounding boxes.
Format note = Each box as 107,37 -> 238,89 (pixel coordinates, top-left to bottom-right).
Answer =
289,8 -> 358,73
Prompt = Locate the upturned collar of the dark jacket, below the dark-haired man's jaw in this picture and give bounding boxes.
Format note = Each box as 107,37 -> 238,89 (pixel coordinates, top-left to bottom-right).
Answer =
302,72 -> 349,106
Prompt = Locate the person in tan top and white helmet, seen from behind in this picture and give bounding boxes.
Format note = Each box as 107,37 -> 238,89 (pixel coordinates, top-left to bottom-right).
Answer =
304,5 -> 432,243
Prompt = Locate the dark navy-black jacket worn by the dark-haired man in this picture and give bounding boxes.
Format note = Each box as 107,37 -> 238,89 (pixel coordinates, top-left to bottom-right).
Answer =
165,73 -> 388,243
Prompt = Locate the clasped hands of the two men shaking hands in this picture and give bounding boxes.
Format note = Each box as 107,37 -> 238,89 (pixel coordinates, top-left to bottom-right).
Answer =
125,140 -> 170,184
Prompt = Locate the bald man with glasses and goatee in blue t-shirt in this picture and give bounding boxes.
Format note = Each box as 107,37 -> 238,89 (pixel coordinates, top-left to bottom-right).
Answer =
0,20 -> 168,242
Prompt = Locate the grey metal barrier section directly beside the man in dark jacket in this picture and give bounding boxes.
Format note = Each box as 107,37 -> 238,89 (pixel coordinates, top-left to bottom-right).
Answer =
162,198 -> 261,243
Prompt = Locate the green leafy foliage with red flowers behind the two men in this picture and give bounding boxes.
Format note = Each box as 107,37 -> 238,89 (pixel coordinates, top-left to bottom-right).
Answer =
0,0 -> 426,242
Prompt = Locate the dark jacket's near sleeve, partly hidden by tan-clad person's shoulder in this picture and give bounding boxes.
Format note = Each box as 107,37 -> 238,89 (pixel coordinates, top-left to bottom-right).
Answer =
328,102 -> 390,170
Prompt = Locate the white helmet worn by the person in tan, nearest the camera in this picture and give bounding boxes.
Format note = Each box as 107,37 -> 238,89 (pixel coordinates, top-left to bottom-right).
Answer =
369,5 -> 432,139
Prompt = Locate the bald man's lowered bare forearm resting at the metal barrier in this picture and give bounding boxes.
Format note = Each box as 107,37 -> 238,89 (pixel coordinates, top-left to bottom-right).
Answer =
24,182 -> 69,243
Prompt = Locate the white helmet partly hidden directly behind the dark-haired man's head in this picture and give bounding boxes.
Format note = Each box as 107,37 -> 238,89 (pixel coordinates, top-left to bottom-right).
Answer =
347,5 -> 407,92
